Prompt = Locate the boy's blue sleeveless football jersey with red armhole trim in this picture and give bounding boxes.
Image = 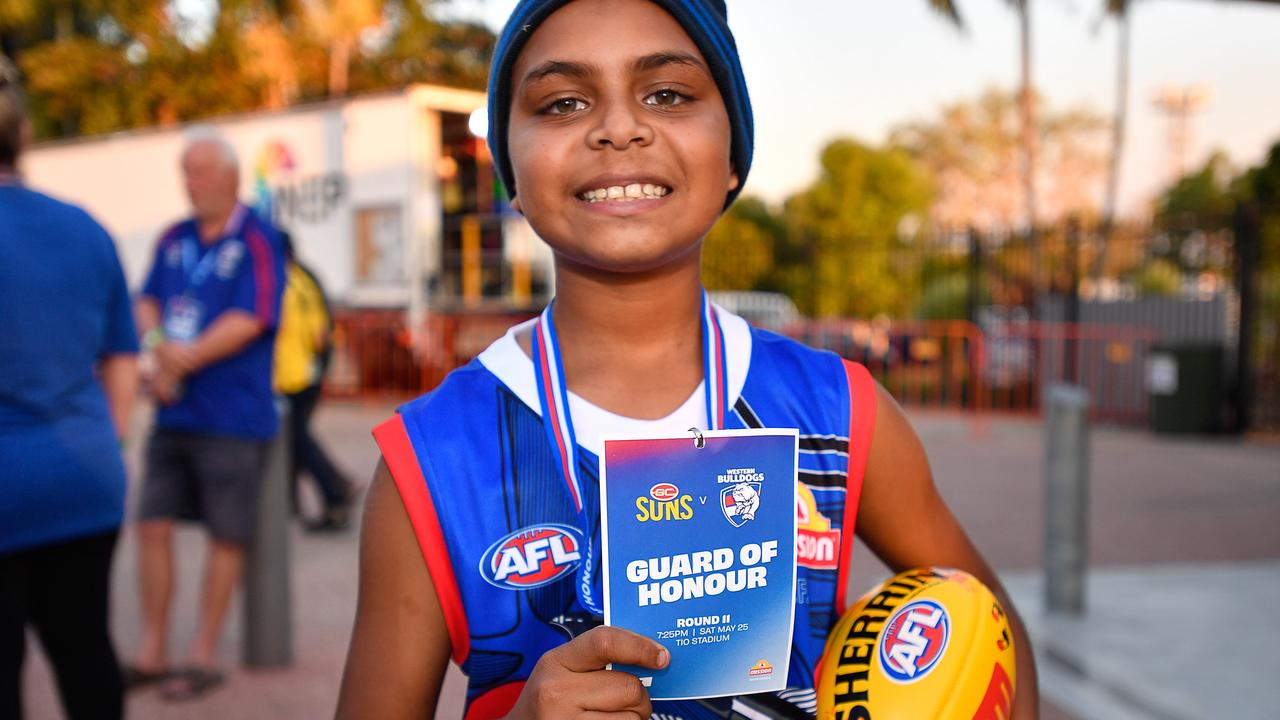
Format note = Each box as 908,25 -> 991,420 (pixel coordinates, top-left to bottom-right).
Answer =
374,309 -> 876,720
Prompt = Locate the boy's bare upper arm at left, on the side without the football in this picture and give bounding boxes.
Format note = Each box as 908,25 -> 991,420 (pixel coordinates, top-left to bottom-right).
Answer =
337,462 -> 449,720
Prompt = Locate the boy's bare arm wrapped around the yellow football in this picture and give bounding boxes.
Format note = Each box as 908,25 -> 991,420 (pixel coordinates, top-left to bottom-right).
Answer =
858,384 -> 1039,720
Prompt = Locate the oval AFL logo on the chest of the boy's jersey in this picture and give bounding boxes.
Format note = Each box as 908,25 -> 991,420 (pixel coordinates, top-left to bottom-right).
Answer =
480,524 -> 582,591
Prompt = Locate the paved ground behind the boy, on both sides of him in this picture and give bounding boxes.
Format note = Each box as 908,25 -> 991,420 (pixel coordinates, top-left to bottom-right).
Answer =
24,405 -> 1280,720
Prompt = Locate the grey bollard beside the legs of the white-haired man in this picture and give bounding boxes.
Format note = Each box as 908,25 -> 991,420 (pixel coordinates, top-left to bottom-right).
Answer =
241,401 -> 293,667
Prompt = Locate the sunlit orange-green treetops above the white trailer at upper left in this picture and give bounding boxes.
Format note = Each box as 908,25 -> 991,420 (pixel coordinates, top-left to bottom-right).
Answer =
0,0 -> 494,138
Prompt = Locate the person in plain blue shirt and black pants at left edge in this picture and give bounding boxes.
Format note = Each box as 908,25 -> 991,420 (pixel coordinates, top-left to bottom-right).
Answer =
0,56 -> 138,720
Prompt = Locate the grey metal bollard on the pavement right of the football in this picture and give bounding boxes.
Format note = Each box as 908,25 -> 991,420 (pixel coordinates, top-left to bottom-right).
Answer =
1044,384 -> 1089,615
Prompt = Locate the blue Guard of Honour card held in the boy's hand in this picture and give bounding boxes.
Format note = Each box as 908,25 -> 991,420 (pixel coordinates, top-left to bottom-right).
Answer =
600,429 -> 799,700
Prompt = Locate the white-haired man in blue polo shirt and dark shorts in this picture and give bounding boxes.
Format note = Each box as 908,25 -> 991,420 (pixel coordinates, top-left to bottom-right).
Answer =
127,131 -> 284,700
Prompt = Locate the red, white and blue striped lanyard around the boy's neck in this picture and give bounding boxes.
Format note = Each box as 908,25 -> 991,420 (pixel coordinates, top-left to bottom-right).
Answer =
532,290 -> 726,615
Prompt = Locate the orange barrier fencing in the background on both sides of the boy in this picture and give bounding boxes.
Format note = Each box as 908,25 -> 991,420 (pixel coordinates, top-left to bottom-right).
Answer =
325,310 -> 1158,432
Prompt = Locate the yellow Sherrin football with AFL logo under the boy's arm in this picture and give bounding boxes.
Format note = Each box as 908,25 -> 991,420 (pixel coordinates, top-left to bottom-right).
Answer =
818,568 -> 1015,720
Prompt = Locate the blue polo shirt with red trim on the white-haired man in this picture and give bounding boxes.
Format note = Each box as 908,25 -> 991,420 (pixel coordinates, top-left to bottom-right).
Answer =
142,205 -> 284,439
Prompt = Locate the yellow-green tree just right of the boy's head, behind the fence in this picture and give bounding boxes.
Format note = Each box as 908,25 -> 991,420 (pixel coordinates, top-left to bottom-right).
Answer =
785,140 -> 933,316
